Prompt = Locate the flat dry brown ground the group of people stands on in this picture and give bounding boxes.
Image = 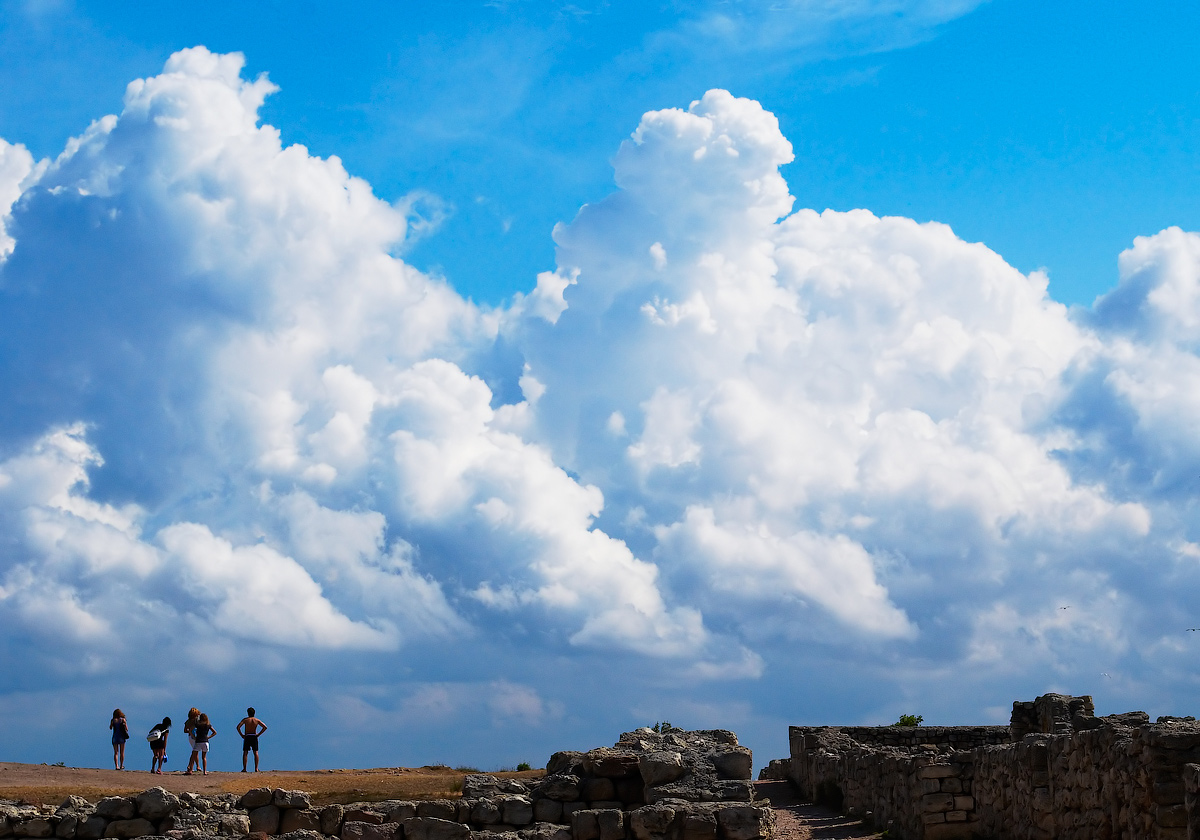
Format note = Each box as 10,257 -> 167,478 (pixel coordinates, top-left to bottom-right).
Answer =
0,762 -> 544,805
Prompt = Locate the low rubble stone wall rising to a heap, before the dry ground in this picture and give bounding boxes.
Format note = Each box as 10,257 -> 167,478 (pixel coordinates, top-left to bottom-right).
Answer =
0,727 -> 774,840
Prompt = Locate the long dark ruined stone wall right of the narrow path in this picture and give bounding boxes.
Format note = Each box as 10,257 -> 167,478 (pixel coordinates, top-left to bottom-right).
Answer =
782,694 -> 1200,840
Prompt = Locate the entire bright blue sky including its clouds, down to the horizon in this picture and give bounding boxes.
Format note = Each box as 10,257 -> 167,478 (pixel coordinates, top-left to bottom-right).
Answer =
0,0 -> 1200,768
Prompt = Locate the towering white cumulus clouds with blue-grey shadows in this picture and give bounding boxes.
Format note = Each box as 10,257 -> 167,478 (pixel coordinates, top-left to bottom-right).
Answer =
0,47 -> 1200,768
